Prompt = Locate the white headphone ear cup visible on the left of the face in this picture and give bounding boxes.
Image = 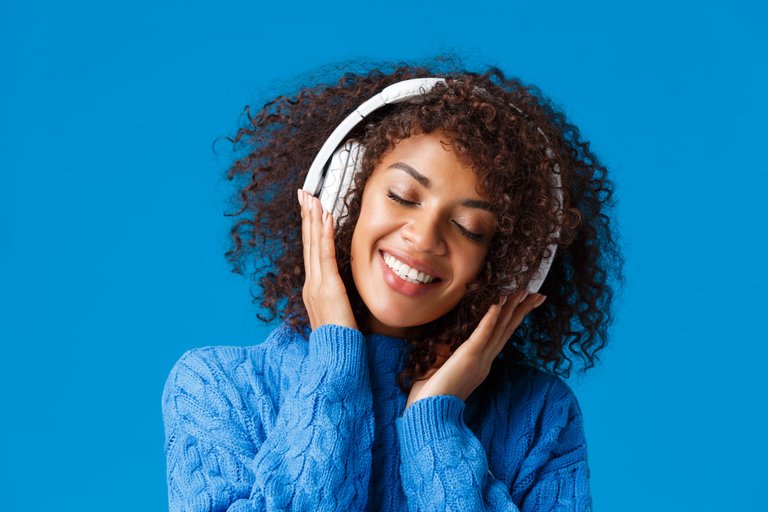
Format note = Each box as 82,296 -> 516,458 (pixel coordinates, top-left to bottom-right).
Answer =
320,139 -> 365,225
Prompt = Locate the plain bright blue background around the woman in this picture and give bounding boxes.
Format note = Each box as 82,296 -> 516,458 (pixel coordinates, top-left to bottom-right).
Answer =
0,0 -> 768,511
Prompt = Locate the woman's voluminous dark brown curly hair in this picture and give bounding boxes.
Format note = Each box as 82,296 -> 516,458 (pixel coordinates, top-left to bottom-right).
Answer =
226,59 -> 623,390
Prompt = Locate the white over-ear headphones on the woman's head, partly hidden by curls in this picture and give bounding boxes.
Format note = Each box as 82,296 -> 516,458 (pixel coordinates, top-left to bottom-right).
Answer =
302,78 -> 563,293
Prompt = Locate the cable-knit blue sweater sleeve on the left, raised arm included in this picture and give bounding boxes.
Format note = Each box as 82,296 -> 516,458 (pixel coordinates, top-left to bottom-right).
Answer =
163,325 -> 373,512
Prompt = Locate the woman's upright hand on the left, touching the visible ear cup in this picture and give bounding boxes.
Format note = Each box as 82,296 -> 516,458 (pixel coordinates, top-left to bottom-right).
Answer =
298,189 -> 357,331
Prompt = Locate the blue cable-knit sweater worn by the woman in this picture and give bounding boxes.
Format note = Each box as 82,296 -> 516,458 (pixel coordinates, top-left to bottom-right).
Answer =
163,325 -> 591,512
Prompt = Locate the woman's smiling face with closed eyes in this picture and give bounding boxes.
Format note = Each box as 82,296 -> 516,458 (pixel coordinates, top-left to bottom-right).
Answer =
351,132 -> 496,336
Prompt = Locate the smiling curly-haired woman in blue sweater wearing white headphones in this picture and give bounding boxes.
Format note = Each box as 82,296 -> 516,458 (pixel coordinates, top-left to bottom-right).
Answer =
163,59 -> 621,512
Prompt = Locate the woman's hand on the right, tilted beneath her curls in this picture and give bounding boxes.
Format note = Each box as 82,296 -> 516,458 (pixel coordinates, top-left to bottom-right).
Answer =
405,290 -> 546,408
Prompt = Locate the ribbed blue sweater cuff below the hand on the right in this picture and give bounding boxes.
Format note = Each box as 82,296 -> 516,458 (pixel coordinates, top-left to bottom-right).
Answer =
397,395 -> 471,457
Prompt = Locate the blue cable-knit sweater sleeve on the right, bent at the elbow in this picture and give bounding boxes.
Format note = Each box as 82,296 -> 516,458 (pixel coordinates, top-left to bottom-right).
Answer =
397,381 -> 591,512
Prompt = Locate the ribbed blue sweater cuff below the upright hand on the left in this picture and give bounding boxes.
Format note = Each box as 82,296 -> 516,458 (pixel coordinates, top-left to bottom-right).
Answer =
309,324 -> 367,383
